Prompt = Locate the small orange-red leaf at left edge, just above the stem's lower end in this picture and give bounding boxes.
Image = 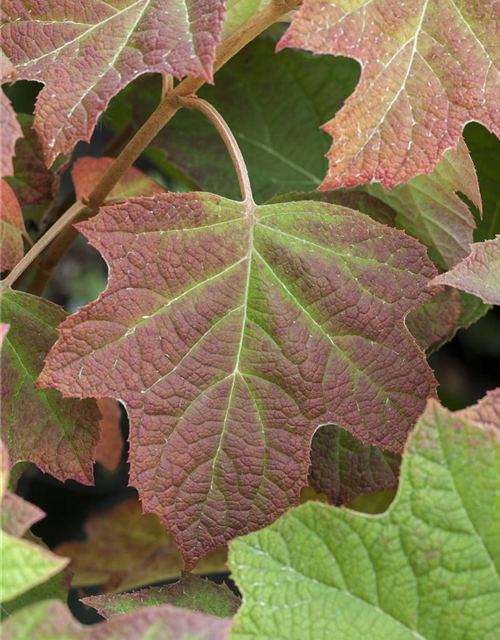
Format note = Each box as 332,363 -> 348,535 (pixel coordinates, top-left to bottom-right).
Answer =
0,178 -> 24,271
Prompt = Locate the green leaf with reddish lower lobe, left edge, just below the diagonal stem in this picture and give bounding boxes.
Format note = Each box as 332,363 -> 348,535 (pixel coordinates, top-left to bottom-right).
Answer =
0,291 -> 100,484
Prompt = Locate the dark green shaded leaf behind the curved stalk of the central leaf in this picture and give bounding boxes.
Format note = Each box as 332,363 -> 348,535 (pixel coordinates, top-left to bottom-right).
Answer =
137,37 -> 359,202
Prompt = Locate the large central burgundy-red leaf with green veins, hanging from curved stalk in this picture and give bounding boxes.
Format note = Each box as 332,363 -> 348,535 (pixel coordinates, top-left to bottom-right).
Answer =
39,193 -> 435,568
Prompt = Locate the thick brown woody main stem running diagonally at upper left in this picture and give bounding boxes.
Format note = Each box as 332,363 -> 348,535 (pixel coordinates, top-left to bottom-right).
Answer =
24,0 -> 302,295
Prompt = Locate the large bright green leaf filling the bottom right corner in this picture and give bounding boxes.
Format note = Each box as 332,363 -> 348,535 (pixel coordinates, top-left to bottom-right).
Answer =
229,401 -> 500,640
